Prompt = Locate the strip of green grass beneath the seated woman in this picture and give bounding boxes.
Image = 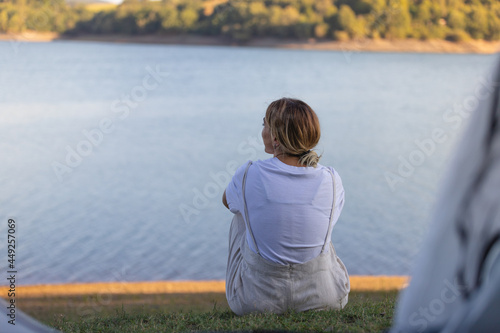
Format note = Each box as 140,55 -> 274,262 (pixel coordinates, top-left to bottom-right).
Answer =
18,292 -> 397,333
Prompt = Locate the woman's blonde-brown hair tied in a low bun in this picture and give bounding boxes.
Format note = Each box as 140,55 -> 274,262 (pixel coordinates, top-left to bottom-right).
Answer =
265,98 -> 321,167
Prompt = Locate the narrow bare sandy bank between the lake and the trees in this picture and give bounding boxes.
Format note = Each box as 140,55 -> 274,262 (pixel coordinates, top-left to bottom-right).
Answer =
0,31 -> 500,55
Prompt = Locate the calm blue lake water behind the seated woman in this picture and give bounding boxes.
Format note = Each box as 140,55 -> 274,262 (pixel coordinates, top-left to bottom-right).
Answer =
0,41 -> 495,284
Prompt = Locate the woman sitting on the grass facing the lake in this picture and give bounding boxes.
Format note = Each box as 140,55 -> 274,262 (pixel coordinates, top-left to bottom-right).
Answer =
222,98 -> 350,315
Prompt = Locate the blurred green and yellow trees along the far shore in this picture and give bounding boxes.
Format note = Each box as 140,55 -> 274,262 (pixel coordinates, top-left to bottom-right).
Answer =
0,0 -> 500,42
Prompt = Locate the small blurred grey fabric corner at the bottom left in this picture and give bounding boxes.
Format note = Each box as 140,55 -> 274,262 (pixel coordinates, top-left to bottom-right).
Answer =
0,298 -> 59,333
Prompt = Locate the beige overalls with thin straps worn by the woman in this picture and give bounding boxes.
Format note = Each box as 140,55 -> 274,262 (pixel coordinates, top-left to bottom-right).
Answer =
226,162 -> 350,315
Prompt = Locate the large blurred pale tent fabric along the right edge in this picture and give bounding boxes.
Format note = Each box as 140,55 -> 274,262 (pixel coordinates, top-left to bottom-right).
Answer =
391,56 -> 500,333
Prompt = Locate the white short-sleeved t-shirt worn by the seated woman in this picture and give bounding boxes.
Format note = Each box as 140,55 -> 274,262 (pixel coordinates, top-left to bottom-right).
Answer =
226,158 -> 344,264
